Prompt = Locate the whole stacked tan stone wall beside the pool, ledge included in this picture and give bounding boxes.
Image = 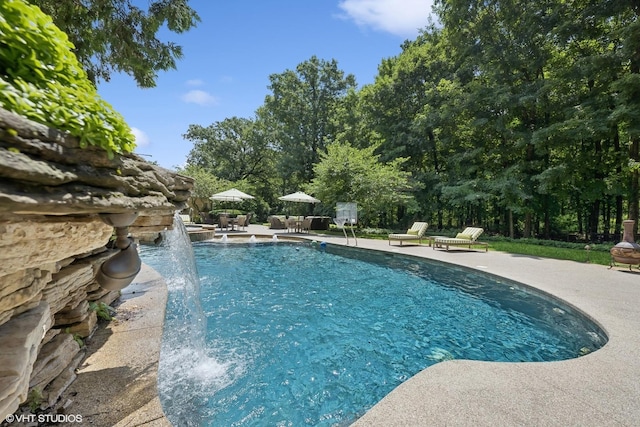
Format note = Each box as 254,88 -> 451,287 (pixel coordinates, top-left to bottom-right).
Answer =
0,108 -> 193,420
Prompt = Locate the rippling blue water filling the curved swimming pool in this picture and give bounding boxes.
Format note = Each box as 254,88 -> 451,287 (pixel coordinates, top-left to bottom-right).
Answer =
142,236 -> 606,426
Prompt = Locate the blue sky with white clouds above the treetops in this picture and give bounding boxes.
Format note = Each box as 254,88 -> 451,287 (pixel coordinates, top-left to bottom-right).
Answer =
98,0 -> 433,169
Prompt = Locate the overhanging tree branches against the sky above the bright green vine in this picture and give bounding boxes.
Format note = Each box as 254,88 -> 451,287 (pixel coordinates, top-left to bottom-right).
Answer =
28,0 -> 200,87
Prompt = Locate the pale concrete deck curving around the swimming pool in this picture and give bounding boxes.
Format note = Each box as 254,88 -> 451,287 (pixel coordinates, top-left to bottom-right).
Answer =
68,225 -> 640,427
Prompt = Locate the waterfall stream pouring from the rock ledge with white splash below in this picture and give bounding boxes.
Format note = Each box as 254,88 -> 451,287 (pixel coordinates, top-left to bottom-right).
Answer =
140,215 -> 242,426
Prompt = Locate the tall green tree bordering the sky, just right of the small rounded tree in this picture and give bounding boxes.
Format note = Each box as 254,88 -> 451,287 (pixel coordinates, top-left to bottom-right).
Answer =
359,27 -> 462,227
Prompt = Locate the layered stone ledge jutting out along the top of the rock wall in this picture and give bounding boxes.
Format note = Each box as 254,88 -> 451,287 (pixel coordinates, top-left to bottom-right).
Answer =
0,109 -> 193,216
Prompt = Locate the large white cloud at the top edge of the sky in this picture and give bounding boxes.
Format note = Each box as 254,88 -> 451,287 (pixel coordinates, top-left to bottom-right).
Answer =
338,0 -> 433,38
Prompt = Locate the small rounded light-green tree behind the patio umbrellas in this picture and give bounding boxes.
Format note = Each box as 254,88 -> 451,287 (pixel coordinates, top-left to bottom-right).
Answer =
307,143 -> 415,229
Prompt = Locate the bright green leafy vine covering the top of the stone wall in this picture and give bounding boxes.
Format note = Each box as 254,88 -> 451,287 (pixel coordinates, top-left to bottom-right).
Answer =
0,0 -> 135,158
